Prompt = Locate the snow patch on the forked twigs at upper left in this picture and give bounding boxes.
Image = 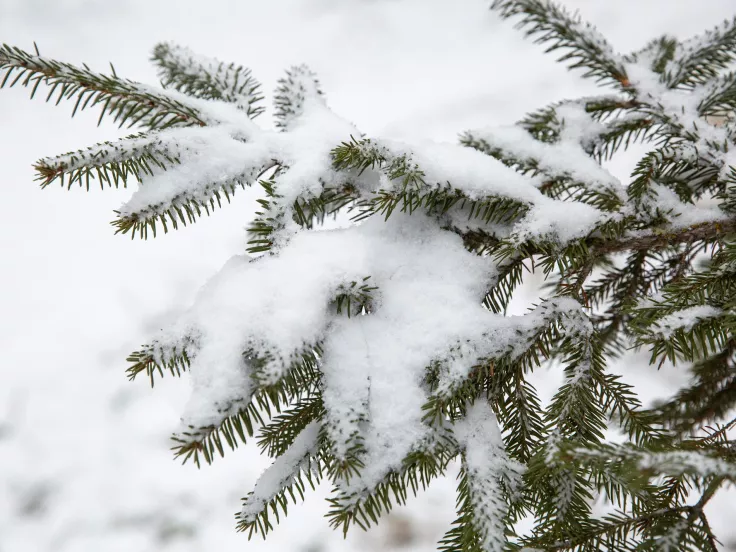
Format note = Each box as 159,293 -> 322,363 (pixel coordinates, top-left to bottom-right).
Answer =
117,85 -> 357,235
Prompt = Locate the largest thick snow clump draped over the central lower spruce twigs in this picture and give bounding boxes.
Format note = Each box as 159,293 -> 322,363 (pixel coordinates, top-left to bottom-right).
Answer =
168,214 -> 500,489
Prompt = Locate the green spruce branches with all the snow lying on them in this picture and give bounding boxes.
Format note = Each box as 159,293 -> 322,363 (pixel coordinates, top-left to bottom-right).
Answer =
0,0 -> 736,552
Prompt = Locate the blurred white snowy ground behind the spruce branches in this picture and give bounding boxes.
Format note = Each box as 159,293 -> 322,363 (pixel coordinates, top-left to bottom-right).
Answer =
0,0 -> 736,552
